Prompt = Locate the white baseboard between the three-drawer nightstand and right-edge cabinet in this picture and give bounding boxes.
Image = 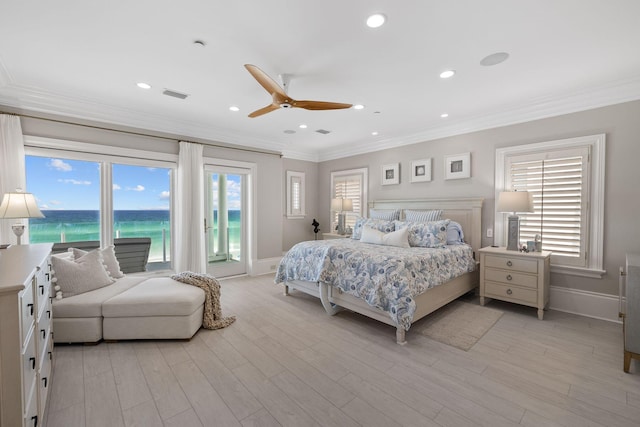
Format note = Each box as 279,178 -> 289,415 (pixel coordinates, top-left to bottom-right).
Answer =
549,286 -> 621,323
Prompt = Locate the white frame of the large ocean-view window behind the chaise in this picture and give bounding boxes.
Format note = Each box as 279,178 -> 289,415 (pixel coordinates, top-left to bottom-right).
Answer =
24,135 -> 178,263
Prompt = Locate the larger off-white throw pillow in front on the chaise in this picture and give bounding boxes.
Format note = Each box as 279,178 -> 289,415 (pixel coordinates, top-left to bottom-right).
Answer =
51,251 -> 114,298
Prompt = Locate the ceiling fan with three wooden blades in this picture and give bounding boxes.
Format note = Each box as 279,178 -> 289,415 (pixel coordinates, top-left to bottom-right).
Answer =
244,64 -> 352,117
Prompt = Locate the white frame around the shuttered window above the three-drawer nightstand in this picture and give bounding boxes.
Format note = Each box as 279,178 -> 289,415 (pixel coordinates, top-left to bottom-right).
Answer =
494,134 -> 606,278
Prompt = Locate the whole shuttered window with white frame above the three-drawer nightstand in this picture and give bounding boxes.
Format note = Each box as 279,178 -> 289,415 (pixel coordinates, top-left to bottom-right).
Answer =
496,135 -> 605,277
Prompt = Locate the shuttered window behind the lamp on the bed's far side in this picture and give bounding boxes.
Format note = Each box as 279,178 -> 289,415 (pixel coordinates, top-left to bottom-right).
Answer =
331,168 -> 369,230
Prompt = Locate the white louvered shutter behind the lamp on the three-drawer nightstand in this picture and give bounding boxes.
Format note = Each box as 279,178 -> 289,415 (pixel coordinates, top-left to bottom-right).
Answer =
505,147 -> 591,267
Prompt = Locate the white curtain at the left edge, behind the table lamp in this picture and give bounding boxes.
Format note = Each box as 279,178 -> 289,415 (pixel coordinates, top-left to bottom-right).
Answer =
0,114 -> 29,244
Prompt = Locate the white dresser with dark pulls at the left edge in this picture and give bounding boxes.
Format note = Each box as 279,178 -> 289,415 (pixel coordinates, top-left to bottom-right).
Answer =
0,243 -> 53,427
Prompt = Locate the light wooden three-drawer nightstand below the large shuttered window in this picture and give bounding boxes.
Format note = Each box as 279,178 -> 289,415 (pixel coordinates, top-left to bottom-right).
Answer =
478,247 -> 551,320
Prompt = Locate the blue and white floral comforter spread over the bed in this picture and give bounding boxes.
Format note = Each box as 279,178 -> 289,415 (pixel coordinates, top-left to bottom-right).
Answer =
275,239 -> 476,330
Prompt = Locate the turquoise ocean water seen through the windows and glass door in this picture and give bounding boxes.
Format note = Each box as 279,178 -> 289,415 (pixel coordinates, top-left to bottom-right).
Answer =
29,210 -> 240,262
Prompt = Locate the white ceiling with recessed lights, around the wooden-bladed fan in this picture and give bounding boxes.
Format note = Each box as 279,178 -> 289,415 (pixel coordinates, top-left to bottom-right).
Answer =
0,0 -> 640,161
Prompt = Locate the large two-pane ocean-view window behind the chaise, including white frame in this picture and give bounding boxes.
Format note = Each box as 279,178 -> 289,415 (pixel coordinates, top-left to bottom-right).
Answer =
25,136 -> 176,270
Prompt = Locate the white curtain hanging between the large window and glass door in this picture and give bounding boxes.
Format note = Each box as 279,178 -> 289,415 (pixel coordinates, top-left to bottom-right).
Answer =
174,141 -> 207,273
